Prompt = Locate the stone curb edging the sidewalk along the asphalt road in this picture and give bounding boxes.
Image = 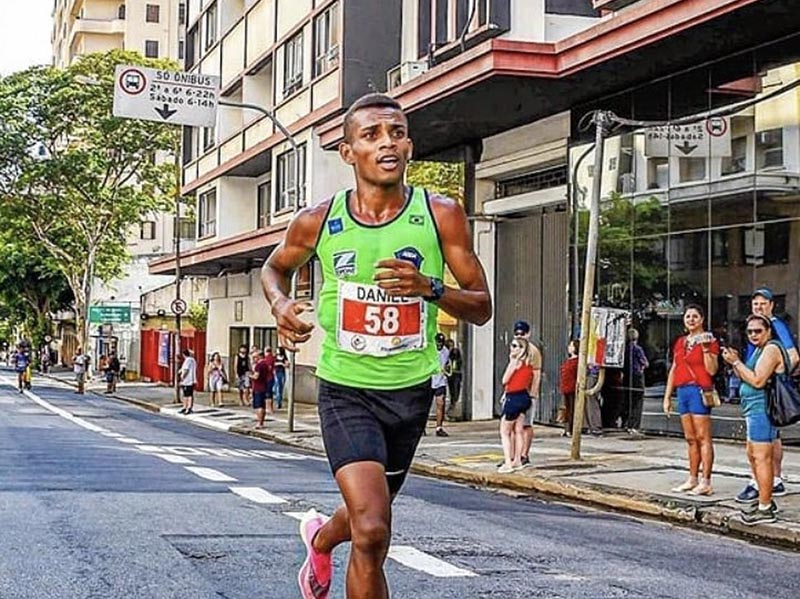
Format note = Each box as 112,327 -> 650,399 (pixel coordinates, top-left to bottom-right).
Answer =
94,394 -> 800,551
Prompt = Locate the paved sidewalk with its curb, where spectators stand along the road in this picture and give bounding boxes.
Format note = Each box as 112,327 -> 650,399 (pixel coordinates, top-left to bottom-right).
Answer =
43,373 -> 800,549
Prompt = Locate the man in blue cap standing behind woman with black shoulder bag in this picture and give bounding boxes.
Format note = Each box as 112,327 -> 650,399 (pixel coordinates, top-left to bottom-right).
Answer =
736,287 -> 800,504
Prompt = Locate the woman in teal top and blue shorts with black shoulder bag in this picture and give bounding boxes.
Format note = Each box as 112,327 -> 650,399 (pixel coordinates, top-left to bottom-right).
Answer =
722,314 -> 789,525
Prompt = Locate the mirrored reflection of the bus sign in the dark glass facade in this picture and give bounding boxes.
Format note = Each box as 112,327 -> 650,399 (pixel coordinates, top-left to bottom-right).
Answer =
644,117 -> 731,158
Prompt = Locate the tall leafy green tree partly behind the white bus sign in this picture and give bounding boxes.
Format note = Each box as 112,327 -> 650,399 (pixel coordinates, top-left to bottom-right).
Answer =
0,50 -> 179,346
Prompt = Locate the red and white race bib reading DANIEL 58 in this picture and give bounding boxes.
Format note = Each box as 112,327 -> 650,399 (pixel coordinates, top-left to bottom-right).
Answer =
336,281 -> 426,357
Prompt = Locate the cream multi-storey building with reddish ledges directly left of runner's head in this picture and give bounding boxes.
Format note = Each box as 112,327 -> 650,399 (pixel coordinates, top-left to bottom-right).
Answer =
150,0 -> 402,400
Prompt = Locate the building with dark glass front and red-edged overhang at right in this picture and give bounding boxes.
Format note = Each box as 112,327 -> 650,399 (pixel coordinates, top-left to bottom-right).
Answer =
319,0 -> 800,434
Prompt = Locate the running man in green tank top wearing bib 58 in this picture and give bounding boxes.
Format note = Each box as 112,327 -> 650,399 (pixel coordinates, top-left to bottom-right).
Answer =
262,94 -> 492,599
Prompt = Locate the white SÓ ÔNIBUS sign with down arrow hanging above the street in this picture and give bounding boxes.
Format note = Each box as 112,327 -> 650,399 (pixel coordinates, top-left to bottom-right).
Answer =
113,65 -> 220,127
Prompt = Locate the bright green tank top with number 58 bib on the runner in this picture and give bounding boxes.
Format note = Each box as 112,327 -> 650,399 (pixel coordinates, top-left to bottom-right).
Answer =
316,188 -> 444,390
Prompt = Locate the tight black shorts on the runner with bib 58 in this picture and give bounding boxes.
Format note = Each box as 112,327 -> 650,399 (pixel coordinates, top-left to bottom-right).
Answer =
318,380 -> 433,495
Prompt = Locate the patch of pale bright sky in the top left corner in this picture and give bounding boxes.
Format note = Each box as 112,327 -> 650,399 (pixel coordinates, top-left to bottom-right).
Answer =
0,0 -> 53,75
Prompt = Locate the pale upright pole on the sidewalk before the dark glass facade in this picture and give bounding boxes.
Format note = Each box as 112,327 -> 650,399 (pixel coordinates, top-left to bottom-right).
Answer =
571,110 -> 610,460
